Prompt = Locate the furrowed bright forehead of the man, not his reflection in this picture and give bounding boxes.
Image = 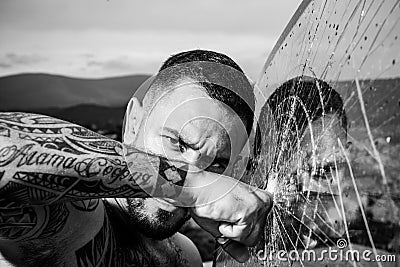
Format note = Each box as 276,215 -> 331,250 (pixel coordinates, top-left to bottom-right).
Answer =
147,84 -> 245,152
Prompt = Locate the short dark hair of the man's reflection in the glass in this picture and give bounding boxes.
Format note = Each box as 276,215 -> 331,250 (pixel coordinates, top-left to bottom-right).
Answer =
255,76 -> 347,158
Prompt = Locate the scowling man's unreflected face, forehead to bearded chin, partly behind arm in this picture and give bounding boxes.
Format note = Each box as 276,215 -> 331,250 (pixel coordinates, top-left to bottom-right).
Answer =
128,84 -> 247,241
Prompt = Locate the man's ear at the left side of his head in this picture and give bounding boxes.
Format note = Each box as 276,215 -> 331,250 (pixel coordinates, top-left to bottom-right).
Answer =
122,97 -> 144,144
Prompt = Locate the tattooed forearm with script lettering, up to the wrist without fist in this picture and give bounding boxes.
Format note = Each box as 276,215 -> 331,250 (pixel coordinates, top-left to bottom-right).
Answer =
0,112 -> 191,205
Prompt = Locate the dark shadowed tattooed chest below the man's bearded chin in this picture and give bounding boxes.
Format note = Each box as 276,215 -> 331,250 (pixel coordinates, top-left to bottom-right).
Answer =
75,207 -> 190,267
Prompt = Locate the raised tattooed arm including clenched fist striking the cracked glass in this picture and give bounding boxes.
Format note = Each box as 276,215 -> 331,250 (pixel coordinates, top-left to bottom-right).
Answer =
0,113 -> 271,264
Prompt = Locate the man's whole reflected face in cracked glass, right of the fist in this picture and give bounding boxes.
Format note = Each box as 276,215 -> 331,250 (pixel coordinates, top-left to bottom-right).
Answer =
267,114 -> 356,248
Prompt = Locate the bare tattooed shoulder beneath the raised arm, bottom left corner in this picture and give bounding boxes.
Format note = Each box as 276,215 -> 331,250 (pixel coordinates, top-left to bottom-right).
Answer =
0,200 -> 104,266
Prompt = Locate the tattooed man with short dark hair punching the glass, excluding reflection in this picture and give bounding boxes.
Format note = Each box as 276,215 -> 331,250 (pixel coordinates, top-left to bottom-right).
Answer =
0,50 -> 271,266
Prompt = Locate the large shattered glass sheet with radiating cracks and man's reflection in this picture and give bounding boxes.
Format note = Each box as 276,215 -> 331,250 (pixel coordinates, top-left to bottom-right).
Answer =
214,0 -> 400,266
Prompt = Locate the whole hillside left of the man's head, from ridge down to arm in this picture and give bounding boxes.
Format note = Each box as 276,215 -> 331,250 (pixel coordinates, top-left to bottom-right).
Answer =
0,74 -> 149,140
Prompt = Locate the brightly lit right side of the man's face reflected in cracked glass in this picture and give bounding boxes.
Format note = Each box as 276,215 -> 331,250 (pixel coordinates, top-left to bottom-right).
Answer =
290,115 -> 349,241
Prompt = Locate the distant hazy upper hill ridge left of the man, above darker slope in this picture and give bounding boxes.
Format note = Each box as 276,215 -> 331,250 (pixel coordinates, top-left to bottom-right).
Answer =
0,74 -> 149,111
